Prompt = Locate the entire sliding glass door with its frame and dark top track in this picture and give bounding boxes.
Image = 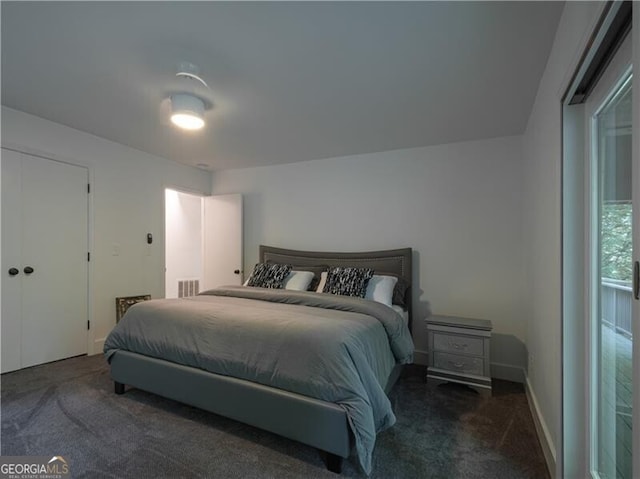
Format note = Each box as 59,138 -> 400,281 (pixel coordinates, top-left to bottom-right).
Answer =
556,1 -> 640,479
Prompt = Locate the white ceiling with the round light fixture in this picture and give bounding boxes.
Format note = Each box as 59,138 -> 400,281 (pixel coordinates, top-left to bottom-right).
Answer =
1,1 -> 563,169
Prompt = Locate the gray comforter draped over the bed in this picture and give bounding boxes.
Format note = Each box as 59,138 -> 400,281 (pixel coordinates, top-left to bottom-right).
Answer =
104,286 -> 413,473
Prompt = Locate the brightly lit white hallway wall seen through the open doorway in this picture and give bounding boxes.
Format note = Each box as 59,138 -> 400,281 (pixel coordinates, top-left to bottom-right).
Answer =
165,189 -> 202,298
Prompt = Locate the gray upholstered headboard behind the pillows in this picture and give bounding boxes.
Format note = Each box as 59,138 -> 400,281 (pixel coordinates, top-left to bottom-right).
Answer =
259,245 -> 413,327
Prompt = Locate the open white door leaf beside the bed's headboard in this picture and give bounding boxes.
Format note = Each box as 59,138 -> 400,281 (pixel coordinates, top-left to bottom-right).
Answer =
201,194 -> 242,291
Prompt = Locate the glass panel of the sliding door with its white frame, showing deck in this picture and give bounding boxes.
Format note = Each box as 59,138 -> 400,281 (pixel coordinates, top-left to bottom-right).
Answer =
586,32 -> 640,479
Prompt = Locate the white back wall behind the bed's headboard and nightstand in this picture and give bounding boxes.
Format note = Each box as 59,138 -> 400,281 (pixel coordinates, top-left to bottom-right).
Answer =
213,137 -> 526,380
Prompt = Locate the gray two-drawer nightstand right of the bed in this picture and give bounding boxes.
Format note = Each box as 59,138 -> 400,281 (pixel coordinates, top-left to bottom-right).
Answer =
426,316 -> 492,392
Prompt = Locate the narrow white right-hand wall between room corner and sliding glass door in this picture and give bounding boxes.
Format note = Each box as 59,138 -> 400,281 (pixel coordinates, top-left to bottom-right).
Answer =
523,2 -> 603,473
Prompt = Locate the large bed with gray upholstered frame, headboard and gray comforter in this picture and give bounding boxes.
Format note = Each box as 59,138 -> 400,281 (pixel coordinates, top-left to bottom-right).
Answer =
105,246 -> 413,473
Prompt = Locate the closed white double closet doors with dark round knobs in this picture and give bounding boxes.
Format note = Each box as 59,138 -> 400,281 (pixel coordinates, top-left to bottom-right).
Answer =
2,149 -> 88,372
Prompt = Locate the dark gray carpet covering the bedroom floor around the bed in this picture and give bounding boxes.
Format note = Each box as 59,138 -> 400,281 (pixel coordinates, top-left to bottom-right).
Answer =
1,355 -> 548,479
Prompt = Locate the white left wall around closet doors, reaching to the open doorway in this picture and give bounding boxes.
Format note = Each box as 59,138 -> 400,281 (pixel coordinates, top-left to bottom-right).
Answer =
2,107 -> 211,353
